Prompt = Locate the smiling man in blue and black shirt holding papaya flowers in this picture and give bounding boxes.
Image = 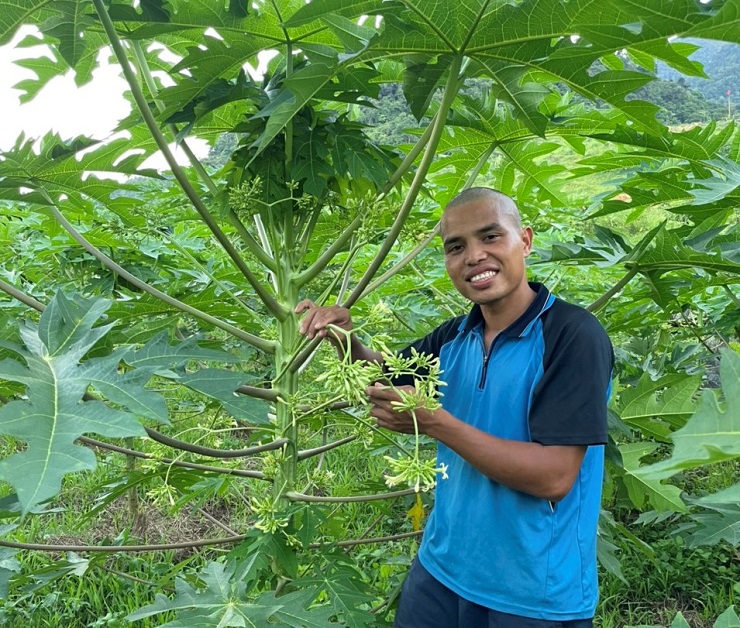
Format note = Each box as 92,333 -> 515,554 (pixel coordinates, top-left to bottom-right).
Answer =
296,188 -> 613,628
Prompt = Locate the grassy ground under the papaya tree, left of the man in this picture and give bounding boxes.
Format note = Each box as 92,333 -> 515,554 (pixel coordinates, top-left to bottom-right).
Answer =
0,410 -> 422,628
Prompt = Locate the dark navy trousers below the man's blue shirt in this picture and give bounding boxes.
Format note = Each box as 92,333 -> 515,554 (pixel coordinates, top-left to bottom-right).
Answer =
393,558 -> 593,628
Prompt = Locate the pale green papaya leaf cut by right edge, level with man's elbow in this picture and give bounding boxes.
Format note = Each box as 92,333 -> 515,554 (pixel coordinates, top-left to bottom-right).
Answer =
636,350 -> 740,480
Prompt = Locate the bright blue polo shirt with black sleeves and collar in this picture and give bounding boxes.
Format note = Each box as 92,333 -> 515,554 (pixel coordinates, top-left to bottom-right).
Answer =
398,283 -> 613,621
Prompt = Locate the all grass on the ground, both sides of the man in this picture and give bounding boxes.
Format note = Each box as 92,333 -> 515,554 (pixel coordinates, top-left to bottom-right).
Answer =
0,412 -> 740,628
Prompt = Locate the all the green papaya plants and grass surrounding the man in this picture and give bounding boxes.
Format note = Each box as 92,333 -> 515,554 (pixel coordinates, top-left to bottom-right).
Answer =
0,0 -> 740,627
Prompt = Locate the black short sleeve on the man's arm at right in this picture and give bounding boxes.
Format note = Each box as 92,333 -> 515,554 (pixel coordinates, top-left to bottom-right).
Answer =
529,300 -> 614,445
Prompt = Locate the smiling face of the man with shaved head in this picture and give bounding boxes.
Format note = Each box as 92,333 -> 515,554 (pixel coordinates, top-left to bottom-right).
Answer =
442,199 -> 532,307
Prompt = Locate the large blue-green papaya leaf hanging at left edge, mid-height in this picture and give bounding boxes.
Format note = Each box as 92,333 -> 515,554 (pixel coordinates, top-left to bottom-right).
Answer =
0,293 -> 152,514
